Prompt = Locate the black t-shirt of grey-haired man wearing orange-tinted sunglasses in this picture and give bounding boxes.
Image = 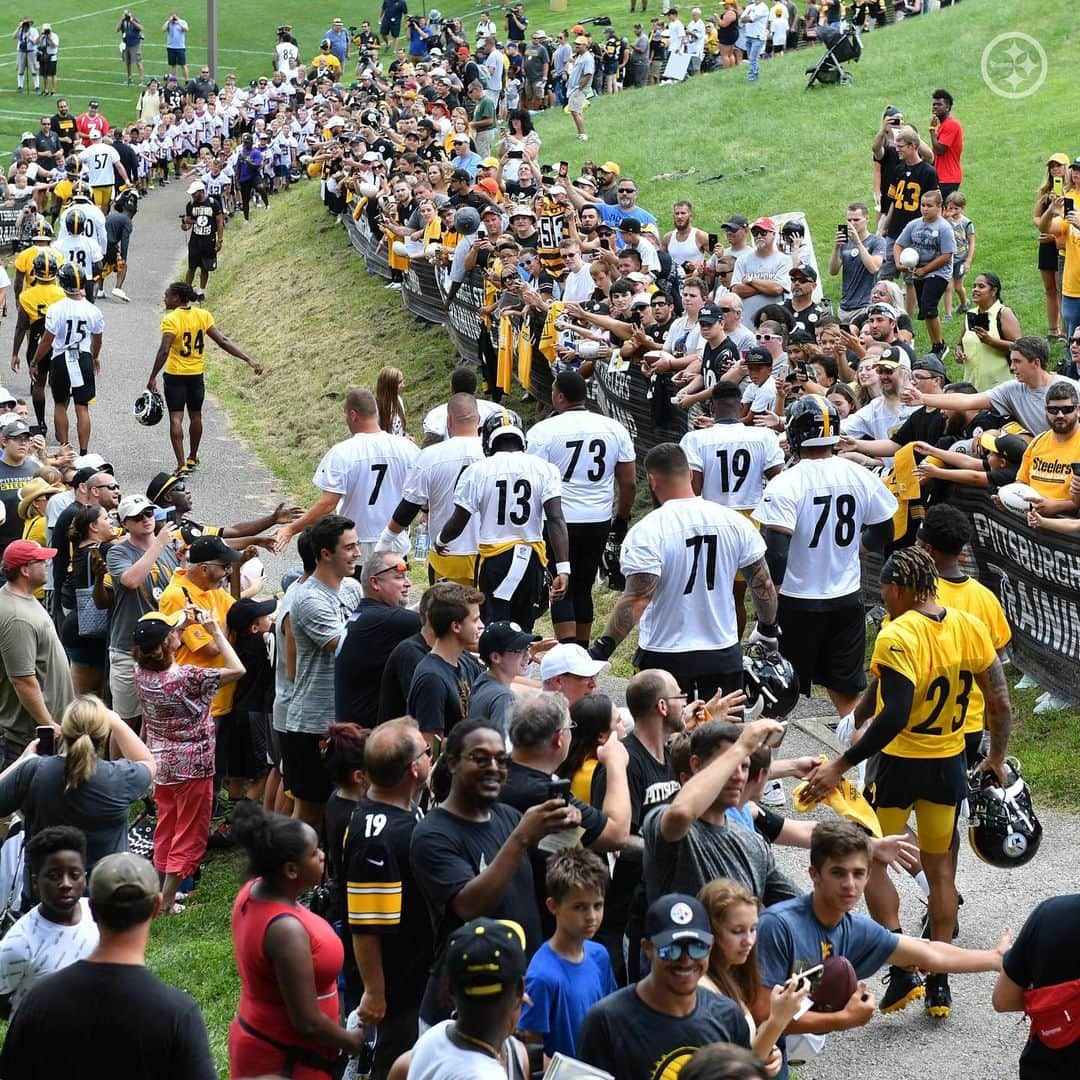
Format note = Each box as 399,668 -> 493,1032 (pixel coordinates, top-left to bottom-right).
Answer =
334,597 -> 420,728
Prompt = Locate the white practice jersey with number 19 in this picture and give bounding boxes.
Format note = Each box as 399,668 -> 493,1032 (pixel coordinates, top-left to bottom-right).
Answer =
679,421 -> 784,510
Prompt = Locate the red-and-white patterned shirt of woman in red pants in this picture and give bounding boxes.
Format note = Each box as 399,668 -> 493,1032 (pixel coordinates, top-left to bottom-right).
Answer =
135,664 -> 221,784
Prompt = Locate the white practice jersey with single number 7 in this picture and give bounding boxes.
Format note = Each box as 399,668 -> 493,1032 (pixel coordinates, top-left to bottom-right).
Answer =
312,431 -> 420,543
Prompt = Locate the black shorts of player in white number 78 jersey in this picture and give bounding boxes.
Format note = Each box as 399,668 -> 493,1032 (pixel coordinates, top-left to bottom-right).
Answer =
777,594 -> 866,698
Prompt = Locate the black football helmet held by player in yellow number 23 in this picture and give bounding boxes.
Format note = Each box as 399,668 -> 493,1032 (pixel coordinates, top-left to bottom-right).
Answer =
968,757 -> 1042,869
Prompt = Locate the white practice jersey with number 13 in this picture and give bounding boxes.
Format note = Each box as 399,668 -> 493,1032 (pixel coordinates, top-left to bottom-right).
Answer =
454,450 -> 563,548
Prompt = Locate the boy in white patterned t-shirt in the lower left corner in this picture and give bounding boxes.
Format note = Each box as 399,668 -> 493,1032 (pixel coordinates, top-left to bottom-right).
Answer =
0,825 -> 97,1020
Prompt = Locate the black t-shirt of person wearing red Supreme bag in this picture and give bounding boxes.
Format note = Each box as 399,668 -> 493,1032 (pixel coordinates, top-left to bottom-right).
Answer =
997,894 -> 1080,1080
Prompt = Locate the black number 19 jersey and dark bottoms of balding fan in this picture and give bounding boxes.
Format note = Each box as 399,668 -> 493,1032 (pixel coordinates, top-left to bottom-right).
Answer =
342,798 -> 434,1015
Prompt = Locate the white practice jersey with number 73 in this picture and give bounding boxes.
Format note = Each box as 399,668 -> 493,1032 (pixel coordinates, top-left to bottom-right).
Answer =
528,409 -> 635,525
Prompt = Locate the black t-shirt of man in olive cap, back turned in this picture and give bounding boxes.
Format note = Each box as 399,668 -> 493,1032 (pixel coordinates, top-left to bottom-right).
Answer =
0,960 -> 217,1080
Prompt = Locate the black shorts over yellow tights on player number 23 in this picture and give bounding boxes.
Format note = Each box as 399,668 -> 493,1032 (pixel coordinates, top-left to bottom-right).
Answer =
864,751 -> 968,855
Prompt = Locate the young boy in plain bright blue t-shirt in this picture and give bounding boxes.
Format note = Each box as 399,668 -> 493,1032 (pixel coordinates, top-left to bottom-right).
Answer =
518,849 -> 616,1057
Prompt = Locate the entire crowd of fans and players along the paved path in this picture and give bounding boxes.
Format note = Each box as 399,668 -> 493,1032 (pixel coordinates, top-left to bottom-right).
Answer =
0,6 -> 1080,1080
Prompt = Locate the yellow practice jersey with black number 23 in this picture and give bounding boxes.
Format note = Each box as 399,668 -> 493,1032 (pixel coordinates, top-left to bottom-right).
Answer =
870,608 -> 997,758
